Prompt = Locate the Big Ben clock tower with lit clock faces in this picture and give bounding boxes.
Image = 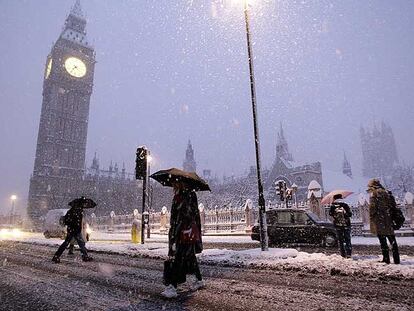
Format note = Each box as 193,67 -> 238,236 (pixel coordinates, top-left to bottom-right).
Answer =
28,0 -> 95,225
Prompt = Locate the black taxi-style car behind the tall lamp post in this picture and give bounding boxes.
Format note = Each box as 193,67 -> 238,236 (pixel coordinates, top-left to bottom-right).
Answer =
251,209 -> 337,247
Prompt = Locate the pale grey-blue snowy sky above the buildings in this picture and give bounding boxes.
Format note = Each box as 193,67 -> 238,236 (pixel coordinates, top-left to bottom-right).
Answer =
0,0 -> 414,213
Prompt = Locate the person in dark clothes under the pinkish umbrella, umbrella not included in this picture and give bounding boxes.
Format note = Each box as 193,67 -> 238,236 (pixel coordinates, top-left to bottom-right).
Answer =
329,194 -> 352,258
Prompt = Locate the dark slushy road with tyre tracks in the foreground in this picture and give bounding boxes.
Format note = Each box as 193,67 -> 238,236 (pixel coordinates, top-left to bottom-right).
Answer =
0,241 -> 414,311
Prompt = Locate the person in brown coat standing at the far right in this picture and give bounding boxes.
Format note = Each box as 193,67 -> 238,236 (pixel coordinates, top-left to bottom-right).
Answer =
367,179 -> 400,264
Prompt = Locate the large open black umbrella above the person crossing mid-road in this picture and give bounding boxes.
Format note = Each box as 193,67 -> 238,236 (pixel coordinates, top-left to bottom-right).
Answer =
150,168 -> 211,191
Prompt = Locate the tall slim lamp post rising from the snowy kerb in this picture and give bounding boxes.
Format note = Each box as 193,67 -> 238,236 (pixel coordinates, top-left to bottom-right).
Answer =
244,0 -> 269,251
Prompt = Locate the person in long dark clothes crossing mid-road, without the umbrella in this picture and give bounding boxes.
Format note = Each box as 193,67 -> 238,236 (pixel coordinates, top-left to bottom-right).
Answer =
161,181 -> 205,298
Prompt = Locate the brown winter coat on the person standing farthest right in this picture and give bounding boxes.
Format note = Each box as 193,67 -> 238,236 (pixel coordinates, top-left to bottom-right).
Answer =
369,188 -> 394,235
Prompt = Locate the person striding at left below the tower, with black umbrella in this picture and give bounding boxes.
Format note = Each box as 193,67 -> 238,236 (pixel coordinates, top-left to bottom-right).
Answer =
52,197 -> 96,263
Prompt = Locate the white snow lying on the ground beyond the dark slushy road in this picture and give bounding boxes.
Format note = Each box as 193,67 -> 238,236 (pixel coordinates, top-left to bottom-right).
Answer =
2,232 -> 414,279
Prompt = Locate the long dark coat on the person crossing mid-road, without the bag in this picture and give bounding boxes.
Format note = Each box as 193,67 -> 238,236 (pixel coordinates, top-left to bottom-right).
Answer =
168,190 -> 203,257
